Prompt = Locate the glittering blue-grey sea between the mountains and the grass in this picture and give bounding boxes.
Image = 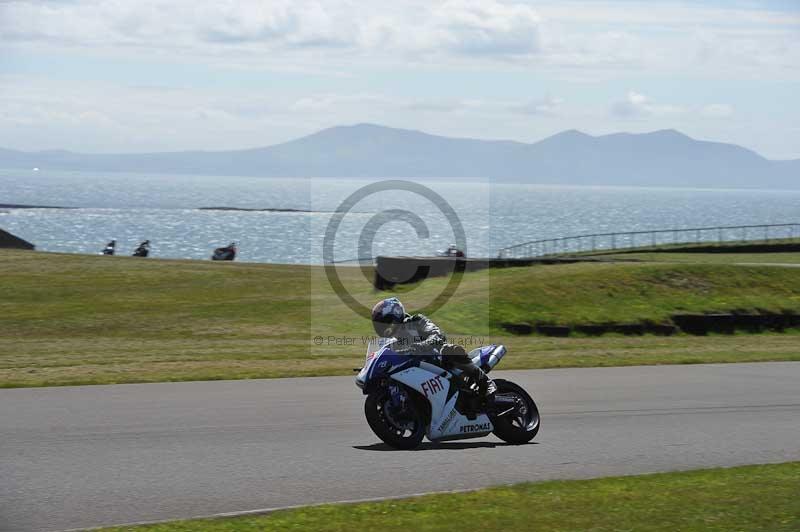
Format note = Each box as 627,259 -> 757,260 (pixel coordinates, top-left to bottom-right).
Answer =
0,169 -> 800,264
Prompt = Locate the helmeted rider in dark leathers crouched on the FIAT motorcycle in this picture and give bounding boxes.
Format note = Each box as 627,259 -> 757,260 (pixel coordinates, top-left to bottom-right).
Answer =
372,297 -> 496,399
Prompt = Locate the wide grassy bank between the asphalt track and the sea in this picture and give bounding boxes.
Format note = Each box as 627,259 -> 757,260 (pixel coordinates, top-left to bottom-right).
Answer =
0,251 -> 800,387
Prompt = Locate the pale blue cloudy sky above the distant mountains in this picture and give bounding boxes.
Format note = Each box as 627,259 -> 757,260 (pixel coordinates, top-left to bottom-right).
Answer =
0,0 -> 800,159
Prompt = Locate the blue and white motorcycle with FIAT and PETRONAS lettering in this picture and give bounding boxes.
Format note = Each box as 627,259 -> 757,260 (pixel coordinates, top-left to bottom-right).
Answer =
356,338 -> 540,449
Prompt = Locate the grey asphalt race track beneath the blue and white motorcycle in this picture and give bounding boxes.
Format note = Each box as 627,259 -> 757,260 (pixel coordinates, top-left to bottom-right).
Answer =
0,362 -> 800,531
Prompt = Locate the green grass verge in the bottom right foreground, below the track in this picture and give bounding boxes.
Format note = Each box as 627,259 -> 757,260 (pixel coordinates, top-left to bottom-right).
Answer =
108,462 -> 800,532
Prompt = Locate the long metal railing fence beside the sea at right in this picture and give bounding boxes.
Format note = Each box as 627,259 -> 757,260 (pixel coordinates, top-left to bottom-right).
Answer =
498,223 -> 800,259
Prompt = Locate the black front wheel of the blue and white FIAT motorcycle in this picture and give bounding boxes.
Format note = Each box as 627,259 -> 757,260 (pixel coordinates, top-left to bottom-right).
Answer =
364,388 -> 425,450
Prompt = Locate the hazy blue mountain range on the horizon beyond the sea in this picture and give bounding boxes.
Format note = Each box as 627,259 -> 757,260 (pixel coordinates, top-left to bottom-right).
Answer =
0,124 -> 800,189
